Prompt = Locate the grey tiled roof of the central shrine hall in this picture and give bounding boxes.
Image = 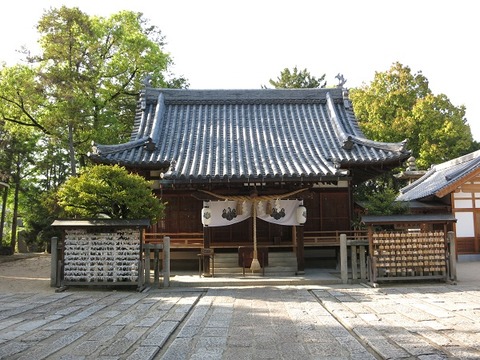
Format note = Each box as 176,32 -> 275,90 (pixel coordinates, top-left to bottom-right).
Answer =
90,87 -> 409,182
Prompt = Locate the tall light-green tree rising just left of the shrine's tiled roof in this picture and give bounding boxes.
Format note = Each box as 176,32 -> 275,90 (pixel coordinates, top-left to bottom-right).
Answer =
31,7 -> 188,174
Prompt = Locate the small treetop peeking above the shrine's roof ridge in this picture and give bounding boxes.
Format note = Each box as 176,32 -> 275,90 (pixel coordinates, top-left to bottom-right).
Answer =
262,66 -> 327,89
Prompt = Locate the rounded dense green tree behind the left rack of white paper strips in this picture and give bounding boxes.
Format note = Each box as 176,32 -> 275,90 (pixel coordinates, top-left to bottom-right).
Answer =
58,165 -> 164,223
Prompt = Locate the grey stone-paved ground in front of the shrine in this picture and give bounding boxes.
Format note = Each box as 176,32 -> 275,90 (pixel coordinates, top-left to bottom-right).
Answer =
0,284 -> 480,360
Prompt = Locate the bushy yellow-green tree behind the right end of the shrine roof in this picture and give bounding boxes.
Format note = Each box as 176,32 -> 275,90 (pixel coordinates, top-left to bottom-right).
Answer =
350,62 -> 476,169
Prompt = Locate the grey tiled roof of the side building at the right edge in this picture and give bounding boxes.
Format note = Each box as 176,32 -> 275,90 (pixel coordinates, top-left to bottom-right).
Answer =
397,150 -> 480,201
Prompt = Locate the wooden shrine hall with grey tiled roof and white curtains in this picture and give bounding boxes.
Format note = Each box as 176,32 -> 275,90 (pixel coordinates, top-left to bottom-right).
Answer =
90,87 -> 410,273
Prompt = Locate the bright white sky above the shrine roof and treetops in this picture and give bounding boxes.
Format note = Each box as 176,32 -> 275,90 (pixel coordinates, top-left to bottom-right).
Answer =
0,0 -> 480,141
